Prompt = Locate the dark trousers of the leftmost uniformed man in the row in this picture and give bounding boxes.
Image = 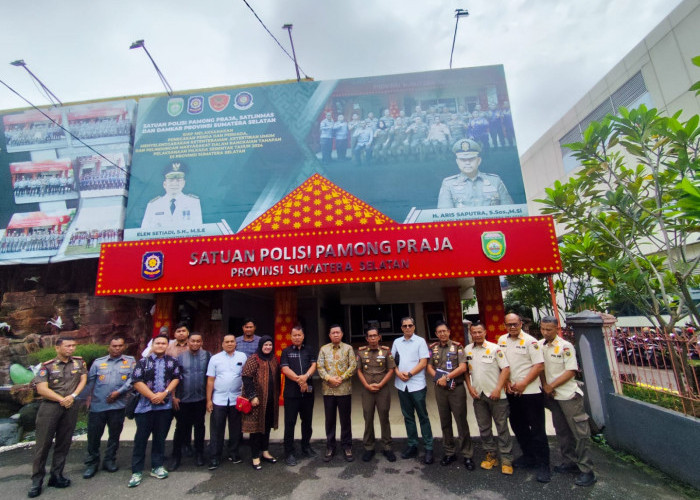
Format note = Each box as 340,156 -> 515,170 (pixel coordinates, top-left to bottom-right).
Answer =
32,401 -> 78,484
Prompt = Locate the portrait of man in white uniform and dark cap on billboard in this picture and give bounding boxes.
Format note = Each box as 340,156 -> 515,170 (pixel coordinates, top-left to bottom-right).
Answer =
141,161 -> 202,229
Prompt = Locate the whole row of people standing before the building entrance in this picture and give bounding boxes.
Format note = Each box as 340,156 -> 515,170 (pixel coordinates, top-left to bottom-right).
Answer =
28,314 -> 596,498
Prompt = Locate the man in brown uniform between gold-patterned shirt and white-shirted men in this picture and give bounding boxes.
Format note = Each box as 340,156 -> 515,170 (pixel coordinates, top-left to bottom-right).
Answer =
357,328 -> 396,462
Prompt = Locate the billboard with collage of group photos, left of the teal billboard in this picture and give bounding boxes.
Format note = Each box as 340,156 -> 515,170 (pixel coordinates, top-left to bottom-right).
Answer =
0,100 -> 136,264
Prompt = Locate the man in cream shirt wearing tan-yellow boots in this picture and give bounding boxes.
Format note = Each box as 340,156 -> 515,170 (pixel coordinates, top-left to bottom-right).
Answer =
464,322 -> 513,475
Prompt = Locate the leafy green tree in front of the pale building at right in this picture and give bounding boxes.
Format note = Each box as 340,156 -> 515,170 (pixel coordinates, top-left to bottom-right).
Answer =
536,101 -> 700,327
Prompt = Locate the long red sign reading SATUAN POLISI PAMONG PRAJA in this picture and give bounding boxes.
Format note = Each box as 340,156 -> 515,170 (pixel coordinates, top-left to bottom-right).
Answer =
96,217 -> 561,295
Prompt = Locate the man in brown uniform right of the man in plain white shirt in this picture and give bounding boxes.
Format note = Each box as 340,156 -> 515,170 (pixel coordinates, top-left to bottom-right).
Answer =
428,321 -> 474,470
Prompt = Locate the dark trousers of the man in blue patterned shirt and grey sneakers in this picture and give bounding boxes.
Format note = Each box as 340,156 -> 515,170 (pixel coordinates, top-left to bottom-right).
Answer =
131,410 -> 173,473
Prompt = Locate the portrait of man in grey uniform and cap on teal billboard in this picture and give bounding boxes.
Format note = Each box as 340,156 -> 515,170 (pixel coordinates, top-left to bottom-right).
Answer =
437,139 -> 513,208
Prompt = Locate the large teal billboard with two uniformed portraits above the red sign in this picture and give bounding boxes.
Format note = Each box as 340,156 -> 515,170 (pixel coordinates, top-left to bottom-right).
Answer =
124,66 -> 527,240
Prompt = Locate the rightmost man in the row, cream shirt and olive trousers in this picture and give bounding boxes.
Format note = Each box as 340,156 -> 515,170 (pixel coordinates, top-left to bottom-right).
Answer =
539,316 -> 596,486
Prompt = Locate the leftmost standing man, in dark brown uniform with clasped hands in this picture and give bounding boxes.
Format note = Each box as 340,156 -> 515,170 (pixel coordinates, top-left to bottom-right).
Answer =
27,337 -> 87,498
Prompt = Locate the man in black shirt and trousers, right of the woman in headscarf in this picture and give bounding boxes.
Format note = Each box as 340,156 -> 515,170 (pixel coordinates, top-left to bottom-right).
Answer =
280,325 -> 316,467
